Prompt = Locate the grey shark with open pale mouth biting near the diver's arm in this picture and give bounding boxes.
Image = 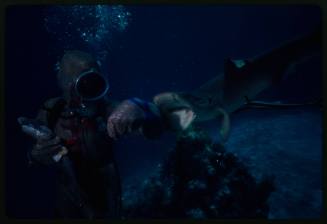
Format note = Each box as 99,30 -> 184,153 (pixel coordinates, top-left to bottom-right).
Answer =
153,28 -> 322,142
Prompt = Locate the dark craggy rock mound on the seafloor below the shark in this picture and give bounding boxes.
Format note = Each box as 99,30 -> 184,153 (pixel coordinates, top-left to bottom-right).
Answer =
123,130 -> 274,219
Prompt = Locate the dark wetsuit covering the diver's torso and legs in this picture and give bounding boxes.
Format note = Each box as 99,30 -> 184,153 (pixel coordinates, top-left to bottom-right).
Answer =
30,98 -> 163,218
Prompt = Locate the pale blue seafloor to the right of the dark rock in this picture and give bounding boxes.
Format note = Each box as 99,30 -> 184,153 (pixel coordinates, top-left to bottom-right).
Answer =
226,108 -> 322,219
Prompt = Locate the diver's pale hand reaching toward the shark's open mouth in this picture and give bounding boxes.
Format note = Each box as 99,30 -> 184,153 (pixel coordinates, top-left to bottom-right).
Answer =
107,100 -> 145,139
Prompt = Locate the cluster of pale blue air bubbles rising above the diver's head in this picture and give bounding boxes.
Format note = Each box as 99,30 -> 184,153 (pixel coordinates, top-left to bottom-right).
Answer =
44,5 -> 131,65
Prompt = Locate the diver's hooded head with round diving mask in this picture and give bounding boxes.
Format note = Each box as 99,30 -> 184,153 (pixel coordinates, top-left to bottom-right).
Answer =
57,51 -> 109,102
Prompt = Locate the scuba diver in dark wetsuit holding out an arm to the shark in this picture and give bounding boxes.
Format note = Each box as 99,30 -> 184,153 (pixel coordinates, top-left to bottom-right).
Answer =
18,51 -> 167,219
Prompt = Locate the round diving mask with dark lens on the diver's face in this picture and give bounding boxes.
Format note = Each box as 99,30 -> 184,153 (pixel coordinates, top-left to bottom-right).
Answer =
74,69 -> 109,101
